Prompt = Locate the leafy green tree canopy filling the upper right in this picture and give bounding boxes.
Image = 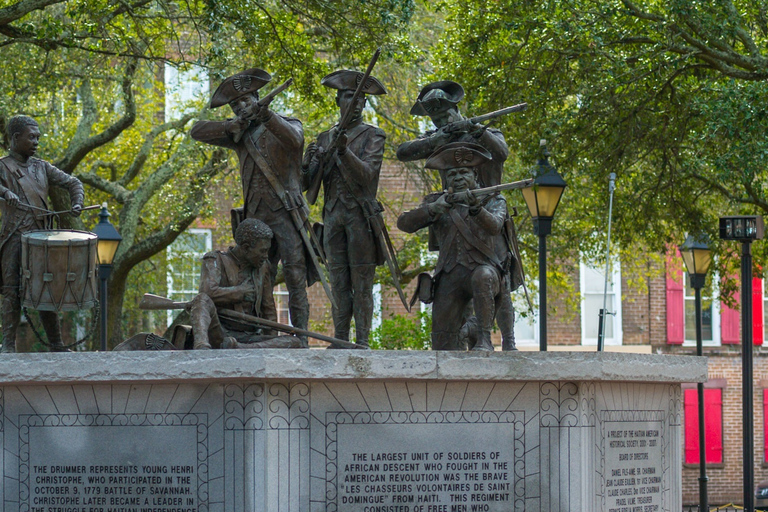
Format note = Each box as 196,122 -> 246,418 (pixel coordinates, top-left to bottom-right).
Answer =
420,0 -> 768,298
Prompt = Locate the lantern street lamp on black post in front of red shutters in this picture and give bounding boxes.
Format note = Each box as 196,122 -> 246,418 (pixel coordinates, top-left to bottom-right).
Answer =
680,235 -> 712,510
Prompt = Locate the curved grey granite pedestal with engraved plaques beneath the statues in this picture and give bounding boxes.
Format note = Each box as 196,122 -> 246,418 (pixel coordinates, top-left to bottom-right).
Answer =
0,350 -> 706,512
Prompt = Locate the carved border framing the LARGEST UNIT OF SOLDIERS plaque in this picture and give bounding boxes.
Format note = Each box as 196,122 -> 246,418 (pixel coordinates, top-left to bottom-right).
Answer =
325,411 -> 525,512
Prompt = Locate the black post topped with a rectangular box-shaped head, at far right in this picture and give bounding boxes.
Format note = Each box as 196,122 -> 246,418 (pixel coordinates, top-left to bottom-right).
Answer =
720,215 -> 765,512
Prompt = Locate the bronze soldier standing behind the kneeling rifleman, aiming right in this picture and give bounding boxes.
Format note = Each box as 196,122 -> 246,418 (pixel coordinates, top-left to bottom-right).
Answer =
397,80 -> 521,350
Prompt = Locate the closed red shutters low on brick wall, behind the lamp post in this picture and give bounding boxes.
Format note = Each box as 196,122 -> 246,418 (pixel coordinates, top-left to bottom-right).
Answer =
684,387 -> 723,464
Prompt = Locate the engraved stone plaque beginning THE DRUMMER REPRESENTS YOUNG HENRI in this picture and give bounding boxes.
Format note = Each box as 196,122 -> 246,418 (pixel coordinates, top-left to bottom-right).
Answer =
19,414 -> 207,512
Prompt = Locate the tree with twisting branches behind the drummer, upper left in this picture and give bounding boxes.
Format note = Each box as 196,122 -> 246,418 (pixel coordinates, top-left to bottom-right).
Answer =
0,0 -> 412,344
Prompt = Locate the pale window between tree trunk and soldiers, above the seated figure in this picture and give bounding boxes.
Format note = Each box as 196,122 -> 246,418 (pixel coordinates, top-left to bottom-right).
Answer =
166,229 -> 212,325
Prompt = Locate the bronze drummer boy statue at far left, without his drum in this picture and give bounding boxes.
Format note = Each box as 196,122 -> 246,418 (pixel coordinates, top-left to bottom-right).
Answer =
0,115 -> 84,352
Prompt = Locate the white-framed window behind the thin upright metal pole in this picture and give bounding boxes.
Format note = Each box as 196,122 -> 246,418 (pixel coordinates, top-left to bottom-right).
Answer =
579,260 -> 622,345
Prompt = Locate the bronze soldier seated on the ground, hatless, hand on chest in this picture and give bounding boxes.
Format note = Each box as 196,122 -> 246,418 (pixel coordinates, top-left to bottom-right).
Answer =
187,218 -> 303,350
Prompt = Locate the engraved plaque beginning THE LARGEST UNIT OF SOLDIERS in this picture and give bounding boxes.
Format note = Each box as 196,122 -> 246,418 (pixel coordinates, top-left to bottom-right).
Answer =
328,411 -> 525,512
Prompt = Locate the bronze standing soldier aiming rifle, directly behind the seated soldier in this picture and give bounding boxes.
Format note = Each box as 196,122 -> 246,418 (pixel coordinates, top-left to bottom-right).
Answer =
190,68 -> 316,341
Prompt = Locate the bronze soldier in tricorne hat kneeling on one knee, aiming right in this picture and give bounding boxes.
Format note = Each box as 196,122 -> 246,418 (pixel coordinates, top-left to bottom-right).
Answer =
397,142 -> 511,350
